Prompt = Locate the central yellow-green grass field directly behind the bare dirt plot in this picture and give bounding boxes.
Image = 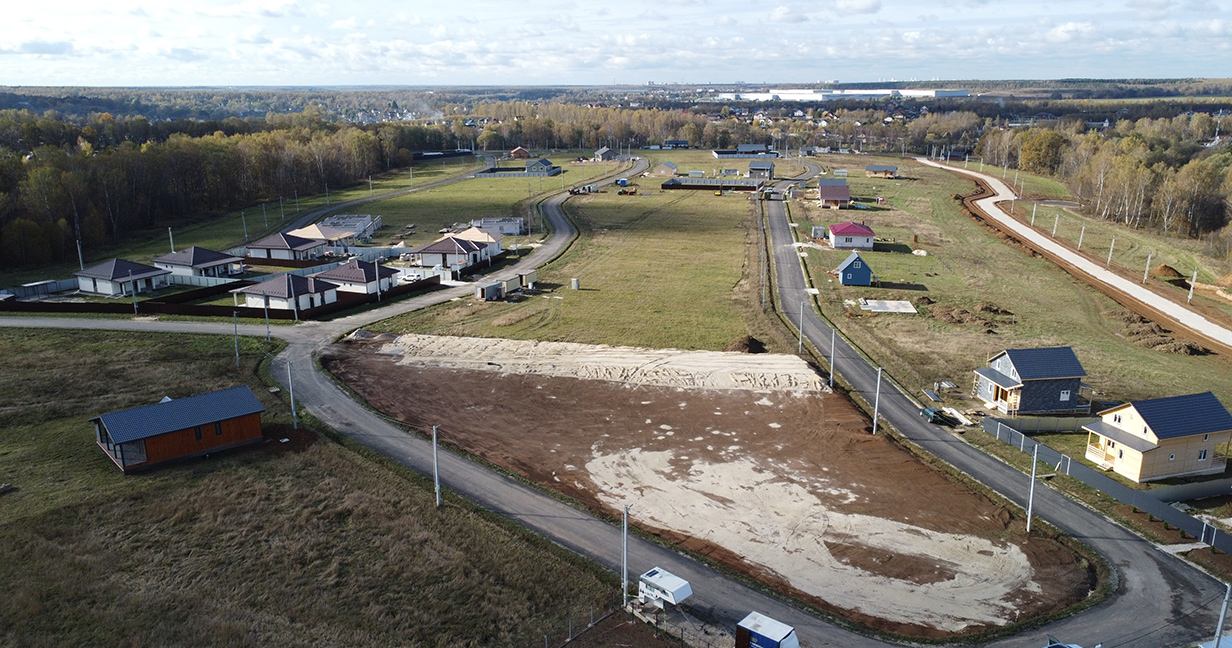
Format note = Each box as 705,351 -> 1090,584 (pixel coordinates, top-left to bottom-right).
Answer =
375,152 -> 775,350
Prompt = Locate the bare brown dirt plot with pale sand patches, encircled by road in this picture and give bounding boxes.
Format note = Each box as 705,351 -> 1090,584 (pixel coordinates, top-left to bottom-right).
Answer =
323,336 -> 1093,637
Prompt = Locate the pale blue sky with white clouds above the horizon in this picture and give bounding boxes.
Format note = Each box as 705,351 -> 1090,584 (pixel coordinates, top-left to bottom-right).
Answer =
0,0 -> 1232,86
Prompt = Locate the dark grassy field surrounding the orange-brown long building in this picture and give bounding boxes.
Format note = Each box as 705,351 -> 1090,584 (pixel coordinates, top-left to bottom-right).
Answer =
0,329 -> 618,646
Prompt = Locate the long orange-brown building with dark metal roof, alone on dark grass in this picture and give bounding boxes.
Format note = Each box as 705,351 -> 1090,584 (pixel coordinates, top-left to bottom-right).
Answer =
90,386 -> 265,473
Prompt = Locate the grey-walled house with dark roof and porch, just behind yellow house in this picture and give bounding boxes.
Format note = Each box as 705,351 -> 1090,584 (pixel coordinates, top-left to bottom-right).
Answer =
975,346 -> 1090,414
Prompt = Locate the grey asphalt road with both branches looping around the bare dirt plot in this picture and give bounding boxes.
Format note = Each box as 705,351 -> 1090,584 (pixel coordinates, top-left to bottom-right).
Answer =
0,161 -> 1223,648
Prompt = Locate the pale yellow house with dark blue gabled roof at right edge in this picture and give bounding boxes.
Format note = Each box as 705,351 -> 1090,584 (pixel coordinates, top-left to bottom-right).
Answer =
1082,392 -> 1232,482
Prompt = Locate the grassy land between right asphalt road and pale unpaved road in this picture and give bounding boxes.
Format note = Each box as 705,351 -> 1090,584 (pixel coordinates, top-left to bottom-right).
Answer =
791,154 -> 1232,403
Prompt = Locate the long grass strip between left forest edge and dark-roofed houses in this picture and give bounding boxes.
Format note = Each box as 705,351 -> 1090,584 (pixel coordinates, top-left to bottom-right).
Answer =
0,158 -> 482,287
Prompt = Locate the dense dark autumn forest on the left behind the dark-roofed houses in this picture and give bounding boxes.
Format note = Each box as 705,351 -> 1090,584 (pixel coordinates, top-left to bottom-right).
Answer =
0,115 -> 456,266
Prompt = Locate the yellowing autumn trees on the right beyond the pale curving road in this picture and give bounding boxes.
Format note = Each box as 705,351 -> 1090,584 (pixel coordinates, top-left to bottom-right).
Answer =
977,113 -> 1232,237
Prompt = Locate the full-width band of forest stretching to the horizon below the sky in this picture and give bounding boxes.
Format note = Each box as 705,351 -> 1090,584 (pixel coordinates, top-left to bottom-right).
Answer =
0,80 -> 1232,266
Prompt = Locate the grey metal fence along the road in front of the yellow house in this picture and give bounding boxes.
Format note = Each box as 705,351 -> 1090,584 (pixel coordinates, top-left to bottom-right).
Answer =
981,416 -> 1232,553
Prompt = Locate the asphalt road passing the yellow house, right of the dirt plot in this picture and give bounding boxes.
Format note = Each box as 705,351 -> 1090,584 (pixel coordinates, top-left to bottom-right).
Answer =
765,165 -> 1225,648
